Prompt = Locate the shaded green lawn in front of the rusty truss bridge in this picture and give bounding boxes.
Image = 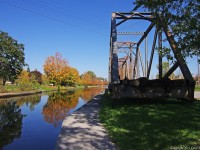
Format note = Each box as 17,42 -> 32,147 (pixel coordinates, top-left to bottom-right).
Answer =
100,95 -> 200,150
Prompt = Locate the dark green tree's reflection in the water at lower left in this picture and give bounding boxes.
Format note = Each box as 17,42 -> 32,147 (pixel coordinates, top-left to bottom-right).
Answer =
0,100 -> 24,149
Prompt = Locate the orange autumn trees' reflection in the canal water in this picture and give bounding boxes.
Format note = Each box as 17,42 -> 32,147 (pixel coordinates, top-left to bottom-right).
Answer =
42,88 -> 104,127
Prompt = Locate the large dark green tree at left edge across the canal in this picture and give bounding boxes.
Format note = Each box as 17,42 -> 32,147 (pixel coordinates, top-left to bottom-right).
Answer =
0,31 -> 25,85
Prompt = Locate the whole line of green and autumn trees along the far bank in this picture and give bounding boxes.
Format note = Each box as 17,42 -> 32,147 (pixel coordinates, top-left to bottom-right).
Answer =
0,31 -> 107,89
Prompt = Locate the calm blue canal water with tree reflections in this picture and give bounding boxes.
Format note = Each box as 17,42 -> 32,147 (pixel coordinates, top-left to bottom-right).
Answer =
0,88 -> 104,150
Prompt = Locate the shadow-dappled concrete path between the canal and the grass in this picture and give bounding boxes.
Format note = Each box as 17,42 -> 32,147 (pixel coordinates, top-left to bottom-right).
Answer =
56,94 -> 116,150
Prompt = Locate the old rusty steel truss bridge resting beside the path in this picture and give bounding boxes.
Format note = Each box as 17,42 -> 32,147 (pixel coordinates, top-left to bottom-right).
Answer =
108,12 -> 195,101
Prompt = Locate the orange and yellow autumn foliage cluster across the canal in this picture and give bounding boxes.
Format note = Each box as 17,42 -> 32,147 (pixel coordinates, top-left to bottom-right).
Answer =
43,53 -> 106,86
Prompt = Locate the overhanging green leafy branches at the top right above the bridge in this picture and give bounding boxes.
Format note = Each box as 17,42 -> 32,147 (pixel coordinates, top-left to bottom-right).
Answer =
133,0 -> 200,57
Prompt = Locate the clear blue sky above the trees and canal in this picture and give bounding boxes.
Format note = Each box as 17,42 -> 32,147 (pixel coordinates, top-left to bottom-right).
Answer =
0,0 -> 198,78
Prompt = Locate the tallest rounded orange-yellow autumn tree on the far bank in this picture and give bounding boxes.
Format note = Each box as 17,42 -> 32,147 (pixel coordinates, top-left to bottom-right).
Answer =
43,52 -> 69,90
